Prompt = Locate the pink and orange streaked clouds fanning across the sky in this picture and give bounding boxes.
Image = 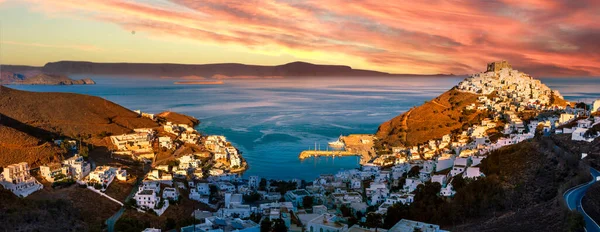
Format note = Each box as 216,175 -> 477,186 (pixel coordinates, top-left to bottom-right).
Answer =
17,0 -> 600,76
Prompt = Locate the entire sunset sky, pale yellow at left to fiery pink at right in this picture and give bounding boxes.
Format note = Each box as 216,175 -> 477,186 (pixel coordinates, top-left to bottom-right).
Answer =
0,0 -> 600,76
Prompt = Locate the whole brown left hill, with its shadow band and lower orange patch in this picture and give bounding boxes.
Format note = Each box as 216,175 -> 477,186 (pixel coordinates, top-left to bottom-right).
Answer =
0,86 -> 158,166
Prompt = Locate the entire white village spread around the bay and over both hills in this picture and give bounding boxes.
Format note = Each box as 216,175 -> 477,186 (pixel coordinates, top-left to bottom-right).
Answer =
0,61 -> 600,232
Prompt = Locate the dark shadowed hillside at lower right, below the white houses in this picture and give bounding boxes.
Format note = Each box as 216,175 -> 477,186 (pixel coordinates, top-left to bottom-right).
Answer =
384,135 -> 600,231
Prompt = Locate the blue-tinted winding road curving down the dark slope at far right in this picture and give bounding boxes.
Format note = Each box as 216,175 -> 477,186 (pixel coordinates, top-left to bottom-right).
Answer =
563,168 -> 600,232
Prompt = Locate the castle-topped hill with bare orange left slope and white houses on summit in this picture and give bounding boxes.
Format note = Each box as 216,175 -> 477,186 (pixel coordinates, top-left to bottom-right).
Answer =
377,61 -> 567,146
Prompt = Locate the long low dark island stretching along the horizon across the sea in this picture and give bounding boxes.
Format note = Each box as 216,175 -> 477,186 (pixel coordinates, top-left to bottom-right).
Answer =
2,61 -> 453,78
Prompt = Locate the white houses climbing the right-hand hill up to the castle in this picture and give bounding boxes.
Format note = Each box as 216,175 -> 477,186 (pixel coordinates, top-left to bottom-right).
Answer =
366,62 -> 600,212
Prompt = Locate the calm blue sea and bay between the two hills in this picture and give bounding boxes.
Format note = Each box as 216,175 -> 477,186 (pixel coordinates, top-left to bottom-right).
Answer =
11,76 -> 600,180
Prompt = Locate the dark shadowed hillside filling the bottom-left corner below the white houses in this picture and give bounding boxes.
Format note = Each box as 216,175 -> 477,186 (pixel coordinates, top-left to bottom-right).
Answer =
0,185 -> 119,231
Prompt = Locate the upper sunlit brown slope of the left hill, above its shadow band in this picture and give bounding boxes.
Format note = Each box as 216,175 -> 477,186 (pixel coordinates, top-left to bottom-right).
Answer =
0,84 -> 158,136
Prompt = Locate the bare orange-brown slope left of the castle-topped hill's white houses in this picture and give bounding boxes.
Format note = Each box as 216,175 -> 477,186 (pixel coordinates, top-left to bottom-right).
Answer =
377,89 -> 483,146
